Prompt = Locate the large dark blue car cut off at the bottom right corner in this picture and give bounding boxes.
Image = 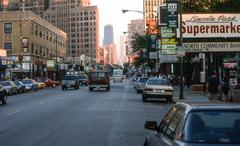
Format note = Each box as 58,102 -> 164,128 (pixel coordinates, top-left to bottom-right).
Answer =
144,103 -> 240,146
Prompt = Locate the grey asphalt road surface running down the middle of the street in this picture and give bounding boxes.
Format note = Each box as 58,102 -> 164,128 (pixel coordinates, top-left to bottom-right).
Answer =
0,80 -> 171,146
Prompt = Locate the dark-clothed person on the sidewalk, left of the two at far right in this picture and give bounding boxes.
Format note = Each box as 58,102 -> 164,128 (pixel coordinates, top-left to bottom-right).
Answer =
207,72 -> 220,102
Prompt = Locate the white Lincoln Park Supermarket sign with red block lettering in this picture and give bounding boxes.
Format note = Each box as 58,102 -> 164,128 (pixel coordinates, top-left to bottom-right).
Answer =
182,14 -> 240,38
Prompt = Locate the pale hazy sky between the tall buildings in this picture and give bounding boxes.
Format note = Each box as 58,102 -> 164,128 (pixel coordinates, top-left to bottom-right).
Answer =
91,0 -> 143,45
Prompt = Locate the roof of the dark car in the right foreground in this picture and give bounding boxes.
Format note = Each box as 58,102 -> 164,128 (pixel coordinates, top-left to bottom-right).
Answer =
176,102 -> 240,112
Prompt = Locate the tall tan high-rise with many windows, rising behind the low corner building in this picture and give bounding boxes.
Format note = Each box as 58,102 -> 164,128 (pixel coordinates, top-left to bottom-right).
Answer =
44,0 -> 99,59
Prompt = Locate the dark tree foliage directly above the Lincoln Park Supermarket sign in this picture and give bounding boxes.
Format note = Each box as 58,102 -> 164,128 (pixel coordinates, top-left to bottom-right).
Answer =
183,0 -> 240,13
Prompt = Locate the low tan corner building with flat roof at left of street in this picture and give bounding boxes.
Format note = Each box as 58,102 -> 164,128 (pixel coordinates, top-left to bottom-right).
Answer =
0,11 -> 67,65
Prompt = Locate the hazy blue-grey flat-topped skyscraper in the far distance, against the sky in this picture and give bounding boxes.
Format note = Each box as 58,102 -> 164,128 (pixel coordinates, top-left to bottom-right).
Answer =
103,25 -> 114,45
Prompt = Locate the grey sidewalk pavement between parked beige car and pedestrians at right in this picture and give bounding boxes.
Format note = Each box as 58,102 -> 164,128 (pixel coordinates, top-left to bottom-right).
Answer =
173,86 -> 209,102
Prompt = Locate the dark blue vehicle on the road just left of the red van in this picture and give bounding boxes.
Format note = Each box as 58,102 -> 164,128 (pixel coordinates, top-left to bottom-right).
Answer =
62,75 -> 80,90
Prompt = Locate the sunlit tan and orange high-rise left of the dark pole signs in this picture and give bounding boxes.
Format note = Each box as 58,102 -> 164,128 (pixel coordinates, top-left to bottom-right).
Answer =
143,0 -> 165,34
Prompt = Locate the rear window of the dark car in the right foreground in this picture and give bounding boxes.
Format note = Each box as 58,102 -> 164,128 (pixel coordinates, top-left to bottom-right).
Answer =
184,110 -> 240,144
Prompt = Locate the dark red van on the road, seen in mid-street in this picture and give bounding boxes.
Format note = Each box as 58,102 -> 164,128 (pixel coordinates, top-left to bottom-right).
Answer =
88,71 -> 110,91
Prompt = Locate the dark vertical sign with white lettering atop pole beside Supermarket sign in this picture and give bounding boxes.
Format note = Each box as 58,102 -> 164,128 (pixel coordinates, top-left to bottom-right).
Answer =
167,3 -> 178,28
